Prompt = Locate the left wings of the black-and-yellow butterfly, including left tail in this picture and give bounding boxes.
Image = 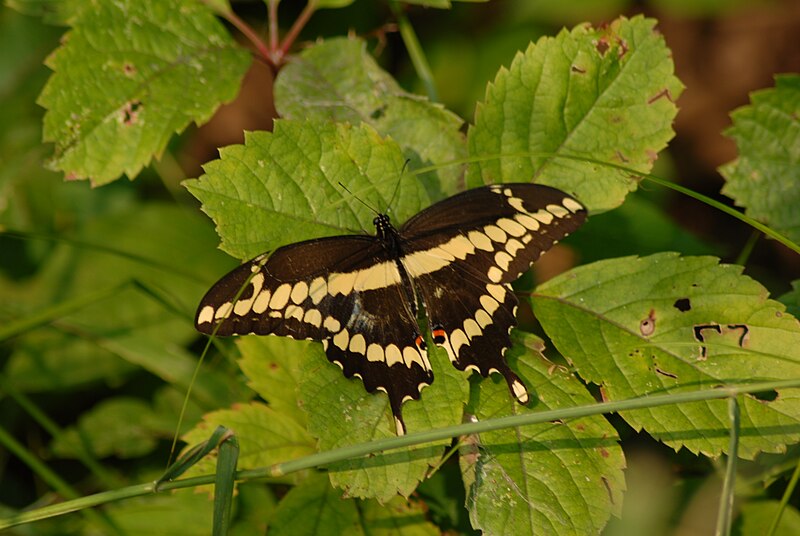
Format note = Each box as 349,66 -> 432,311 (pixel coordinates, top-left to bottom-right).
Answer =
195,235 -> 433,434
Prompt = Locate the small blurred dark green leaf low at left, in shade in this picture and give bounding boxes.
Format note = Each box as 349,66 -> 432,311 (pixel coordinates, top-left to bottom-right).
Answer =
51,397 -> 156,458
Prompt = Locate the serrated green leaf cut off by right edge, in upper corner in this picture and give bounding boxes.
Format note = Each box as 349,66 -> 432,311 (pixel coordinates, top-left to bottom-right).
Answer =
719,75 -> 800,242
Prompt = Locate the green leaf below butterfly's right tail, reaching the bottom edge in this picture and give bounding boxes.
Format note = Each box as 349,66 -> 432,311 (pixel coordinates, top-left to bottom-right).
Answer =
460,335 -> 625,535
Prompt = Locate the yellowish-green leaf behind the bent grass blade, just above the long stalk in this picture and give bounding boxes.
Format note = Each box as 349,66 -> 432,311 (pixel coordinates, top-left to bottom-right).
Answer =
182,402 -> 315,481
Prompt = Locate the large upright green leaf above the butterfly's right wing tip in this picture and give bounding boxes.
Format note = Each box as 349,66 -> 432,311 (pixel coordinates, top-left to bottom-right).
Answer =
468,17 -> 682,213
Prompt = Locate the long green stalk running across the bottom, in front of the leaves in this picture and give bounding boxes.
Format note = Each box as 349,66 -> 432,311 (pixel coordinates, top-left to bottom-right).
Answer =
0,379 -> 800,530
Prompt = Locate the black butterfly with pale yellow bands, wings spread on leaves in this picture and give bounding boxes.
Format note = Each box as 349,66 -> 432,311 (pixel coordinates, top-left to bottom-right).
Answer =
195,183 -> 586,435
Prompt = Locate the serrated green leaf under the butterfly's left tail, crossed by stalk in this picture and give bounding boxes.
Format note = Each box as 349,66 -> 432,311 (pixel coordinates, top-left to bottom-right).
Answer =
300,341 -> 467,502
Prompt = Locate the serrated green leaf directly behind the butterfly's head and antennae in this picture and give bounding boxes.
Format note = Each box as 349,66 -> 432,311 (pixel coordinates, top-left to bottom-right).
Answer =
185,120 -> 429,260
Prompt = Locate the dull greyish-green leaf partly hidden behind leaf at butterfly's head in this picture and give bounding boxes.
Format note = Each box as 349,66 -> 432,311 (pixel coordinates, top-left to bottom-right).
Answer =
275,38 -> 466,198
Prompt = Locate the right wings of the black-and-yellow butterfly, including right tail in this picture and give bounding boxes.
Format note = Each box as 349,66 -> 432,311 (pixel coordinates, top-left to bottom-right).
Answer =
400,184 -> 586,404
